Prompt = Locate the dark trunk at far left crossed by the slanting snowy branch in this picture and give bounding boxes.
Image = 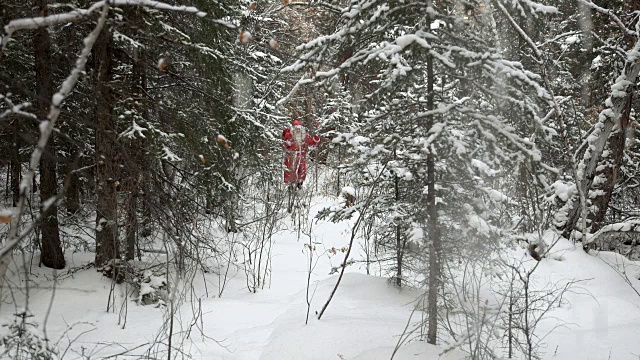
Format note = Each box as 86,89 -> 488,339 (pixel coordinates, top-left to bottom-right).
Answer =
34,0 -> 65,269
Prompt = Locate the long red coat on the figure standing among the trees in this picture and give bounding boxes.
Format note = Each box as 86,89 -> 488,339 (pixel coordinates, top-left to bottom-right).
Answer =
282,129 -> 320,184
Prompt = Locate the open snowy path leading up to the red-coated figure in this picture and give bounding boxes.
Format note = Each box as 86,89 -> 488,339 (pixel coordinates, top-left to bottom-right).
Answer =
188,199 -> 448,360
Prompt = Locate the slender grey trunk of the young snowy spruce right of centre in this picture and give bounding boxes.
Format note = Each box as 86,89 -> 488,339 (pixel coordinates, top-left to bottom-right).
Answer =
427,35 -> 441,344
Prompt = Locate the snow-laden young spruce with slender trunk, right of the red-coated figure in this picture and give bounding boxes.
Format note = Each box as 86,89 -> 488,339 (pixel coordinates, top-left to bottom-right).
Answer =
287,1 -> 555,350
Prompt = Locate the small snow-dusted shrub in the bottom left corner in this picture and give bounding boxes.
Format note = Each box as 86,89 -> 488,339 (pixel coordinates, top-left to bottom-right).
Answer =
0,311 -> 60,360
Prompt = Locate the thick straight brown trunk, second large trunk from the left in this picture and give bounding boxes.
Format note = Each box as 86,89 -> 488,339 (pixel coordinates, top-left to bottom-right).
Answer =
94,28 -> 120,267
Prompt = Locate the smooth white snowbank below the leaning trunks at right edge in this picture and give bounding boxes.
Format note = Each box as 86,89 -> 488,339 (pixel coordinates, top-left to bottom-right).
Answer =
536,240 -> 640,360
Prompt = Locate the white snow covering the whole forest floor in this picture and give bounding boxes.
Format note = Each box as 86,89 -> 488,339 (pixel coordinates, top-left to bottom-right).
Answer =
0,197 -> 640,360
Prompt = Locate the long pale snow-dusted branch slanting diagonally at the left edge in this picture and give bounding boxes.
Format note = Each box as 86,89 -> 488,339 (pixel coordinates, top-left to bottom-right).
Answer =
0,3 -> 109,260
